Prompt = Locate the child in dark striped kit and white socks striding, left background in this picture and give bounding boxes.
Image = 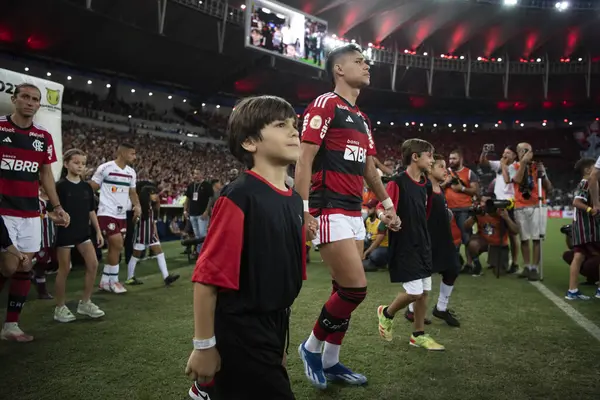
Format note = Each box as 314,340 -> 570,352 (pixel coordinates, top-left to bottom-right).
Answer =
125,185 -> 179,286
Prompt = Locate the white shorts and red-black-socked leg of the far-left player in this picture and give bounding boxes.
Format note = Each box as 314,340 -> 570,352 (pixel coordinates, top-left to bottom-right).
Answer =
0,216 -> 42,342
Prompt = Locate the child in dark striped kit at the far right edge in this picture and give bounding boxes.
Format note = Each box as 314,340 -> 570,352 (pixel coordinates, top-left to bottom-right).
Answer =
565,158 -> 600,300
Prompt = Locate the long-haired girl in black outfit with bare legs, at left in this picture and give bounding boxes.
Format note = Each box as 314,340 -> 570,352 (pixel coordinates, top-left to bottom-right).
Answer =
54,149 -> 104,322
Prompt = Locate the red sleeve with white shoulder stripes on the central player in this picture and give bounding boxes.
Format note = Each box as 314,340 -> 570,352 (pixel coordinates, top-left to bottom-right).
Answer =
302,93 -> 336,146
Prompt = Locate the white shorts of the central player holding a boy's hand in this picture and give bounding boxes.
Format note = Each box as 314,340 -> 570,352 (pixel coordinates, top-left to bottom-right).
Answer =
313,214 -> 367,246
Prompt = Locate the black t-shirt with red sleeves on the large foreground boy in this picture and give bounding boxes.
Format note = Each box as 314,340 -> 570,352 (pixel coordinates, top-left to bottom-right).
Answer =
192,171 -> 306,315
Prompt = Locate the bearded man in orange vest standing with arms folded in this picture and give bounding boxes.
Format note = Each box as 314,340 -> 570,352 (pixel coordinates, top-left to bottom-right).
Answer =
442,150 -> 479,272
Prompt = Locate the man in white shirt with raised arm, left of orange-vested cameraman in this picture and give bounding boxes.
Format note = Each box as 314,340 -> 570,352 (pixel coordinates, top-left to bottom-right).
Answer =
479,144 -> 519,273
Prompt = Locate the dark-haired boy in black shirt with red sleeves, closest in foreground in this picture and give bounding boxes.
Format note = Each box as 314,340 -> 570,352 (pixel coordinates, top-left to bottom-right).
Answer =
186,96 -> 316,400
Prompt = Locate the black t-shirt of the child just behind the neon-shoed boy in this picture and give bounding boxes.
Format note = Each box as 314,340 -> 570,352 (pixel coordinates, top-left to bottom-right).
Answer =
427,189 -> 461,273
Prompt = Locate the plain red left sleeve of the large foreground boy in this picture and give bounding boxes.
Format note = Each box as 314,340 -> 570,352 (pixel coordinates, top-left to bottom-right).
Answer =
192,196 -> 244,290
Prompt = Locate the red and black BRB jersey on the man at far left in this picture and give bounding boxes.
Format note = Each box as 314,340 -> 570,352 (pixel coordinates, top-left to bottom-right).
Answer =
0,116 -> 56,218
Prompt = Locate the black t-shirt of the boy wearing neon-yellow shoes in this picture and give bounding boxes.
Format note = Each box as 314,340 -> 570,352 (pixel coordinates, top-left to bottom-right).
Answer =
386,172 -> 432,283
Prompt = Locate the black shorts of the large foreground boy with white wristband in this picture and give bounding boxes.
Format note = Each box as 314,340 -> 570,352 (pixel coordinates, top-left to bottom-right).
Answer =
206,310 -> 295,400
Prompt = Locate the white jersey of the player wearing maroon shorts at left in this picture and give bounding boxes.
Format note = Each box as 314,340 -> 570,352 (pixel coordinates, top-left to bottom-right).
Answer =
92,161 -> 136,219
